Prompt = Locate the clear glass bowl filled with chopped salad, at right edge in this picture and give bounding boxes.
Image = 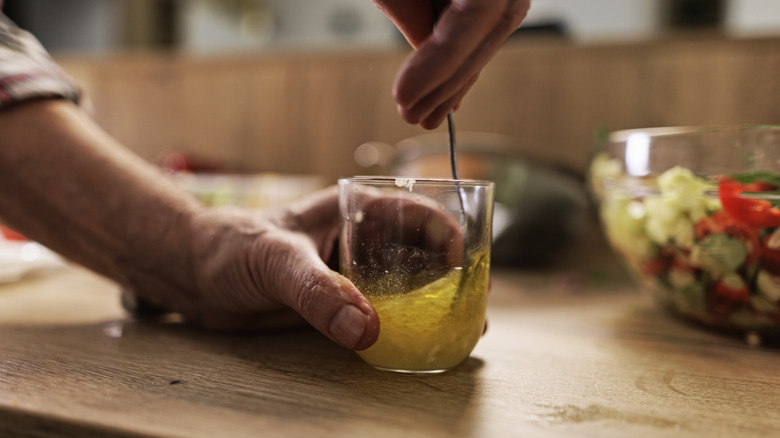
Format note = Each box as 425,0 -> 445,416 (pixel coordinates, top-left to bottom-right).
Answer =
589,126 -> 780,344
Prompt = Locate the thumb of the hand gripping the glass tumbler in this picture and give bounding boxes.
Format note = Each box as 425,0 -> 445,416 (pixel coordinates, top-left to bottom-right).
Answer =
261,231 -> 379,350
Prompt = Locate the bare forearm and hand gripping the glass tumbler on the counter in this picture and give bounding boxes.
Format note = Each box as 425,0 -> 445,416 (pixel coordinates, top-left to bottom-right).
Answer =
0,100 -> 379,349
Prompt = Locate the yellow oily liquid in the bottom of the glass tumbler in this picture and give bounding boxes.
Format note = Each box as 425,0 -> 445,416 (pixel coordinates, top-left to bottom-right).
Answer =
356,252 -> 490,373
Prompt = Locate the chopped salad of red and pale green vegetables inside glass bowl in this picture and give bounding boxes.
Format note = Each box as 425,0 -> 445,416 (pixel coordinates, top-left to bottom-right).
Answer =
591,154 -> 780,342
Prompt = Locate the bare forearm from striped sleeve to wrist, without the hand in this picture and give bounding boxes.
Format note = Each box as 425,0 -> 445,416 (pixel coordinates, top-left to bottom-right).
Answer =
0,100 -> 201,290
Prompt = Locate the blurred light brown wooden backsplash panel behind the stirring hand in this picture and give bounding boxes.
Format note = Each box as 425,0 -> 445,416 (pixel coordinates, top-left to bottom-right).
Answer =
60,38 -> 780,180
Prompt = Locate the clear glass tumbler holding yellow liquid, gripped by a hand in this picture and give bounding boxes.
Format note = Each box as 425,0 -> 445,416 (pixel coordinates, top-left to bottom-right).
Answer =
339,177 -> 494,373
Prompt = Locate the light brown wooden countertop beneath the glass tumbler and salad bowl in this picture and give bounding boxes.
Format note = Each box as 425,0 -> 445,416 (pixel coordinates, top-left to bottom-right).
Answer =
0,238 -> 780,438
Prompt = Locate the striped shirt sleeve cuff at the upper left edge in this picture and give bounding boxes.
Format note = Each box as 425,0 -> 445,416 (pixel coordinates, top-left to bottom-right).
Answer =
0,12 -> 81,110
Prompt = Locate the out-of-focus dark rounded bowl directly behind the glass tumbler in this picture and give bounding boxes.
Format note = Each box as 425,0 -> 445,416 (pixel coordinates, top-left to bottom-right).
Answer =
356,131 -> 590,267
